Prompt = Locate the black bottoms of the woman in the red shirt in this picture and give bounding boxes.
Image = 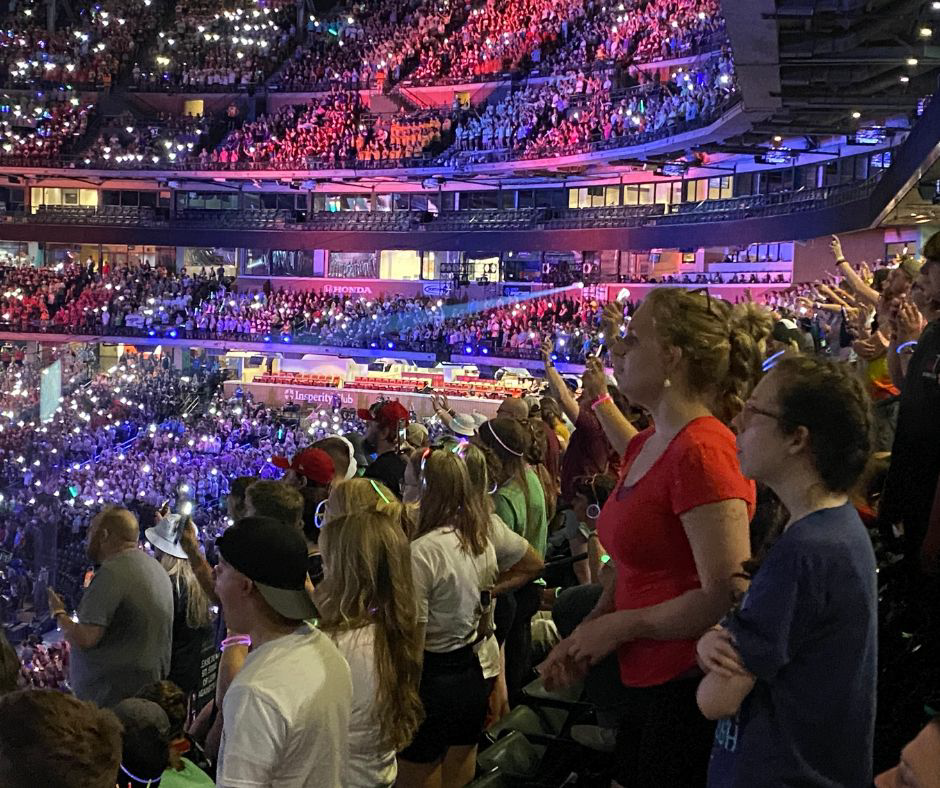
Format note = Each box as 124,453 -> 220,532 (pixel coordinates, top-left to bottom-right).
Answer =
614,677 -> 715,788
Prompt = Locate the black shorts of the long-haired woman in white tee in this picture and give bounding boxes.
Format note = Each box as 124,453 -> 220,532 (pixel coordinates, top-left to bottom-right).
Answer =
399,646 -> 489,763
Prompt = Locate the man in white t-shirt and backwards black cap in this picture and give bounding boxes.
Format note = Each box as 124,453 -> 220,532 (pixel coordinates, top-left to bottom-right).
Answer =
216,517 -> 352,788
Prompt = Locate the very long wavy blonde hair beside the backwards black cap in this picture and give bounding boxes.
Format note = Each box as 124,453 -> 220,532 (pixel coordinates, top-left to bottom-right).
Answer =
317,511 -> 424,751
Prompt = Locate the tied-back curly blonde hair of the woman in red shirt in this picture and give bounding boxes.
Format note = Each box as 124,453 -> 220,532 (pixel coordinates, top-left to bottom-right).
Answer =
643,287 -> 773,424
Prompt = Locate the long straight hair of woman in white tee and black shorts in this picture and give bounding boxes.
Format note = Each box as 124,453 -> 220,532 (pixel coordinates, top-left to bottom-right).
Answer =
414,449 -> 489,555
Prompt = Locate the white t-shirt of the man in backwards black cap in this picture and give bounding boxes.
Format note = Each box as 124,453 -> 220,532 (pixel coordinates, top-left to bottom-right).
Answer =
216,624 -> 352,788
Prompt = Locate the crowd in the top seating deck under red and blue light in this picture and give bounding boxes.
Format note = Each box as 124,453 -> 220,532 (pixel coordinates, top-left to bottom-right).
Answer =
0,0 -> 736,169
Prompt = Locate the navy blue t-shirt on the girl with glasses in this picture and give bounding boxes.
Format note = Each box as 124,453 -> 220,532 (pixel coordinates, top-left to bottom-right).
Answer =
708,504 -> 878,788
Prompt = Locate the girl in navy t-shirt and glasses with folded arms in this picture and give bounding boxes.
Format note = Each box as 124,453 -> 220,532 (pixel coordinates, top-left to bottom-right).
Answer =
697,356 -> 877,788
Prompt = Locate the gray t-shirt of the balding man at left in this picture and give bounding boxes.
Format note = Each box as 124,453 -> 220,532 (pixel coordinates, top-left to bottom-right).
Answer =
70,550 -> 173,707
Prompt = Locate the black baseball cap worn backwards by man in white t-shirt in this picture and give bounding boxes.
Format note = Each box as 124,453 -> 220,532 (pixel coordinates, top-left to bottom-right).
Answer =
216,517 -> 317,621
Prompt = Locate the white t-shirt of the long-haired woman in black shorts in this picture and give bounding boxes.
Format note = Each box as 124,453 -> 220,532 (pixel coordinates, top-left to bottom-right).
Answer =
411,528 -> 499,653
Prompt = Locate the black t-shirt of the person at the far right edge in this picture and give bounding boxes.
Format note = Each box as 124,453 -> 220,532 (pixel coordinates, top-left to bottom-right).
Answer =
880,320 -> 940,557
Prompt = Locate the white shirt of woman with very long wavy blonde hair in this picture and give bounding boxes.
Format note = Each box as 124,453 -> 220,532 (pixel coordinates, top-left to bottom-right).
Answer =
333,626 -> 398,788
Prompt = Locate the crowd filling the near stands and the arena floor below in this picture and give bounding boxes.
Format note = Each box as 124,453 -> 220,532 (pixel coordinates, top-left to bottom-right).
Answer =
0,235 -> 940,788
